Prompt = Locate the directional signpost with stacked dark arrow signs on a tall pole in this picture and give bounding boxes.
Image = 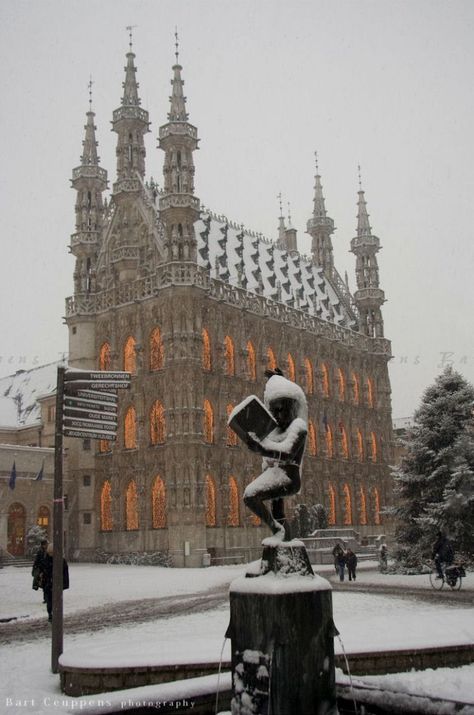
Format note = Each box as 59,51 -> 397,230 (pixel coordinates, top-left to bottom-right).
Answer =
51,367 -> 131,673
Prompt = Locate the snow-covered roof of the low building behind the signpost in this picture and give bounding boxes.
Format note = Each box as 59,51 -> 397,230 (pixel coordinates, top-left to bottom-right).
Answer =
0,361 -> 63,427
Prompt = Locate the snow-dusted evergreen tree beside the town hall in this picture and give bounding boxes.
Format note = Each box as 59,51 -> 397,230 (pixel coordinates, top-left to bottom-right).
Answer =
390,367 -> 474,565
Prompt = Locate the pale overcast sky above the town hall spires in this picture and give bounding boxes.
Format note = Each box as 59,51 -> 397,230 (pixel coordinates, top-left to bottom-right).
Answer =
0,0 -> 474,417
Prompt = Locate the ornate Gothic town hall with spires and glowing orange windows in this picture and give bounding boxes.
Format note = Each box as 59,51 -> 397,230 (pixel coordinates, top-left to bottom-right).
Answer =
66,40 -> 392,566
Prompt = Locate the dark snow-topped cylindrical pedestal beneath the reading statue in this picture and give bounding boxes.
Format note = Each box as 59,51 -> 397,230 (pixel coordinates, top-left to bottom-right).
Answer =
227,539 -> 337,715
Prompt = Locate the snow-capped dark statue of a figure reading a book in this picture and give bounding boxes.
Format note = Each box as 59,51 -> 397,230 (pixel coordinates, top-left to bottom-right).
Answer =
228,370 -> 308,541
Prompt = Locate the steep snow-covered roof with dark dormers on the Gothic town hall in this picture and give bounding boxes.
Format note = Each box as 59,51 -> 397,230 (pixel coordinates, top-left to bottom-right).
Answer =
195,211 -> 354,327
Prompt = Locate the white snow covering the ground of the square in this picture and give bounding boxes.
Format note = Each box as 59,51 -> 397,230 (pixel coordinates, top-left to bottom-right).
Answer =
0,564 -> 474,715
